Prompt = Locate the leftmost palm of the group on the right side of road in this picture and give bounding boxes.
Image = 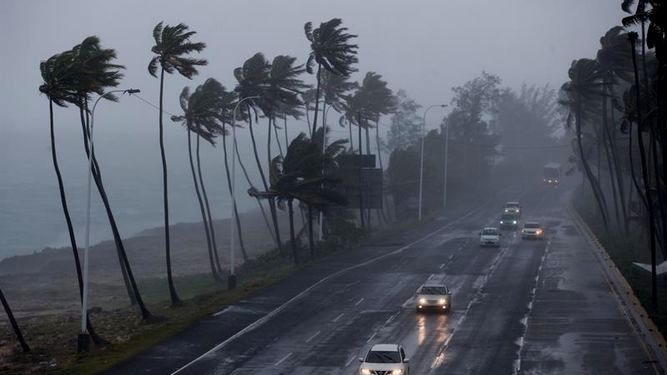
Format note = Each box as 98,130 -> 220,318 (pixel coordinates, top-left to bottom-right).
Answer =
560,59 -> 608,228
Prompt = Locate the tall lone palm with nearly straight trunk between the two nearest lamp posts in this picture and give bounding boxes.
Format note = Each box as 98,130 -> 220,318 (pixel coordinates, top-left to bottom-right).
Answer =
148,22 -> 207,305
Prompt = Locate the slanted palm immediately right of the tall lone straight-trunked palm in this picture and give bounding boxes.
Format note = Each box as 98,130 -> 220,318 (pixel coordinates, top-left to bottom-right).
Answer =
171,86 -> 222,280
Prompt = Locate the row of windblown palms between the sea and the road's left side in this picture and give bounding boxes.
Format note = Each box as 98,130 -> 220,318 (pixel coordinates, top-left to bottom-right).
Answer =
2,18 -> 410,351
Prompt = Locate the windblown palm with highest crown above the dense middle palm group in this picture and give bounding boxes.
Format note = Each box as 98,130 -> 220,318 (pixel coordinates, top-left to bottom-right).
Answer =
303,18 -> 358,134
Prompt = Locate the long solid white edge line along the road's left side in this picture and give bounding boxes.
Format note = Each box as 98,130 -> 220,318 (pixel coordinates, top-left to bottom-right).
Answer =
171,206 -> 490,375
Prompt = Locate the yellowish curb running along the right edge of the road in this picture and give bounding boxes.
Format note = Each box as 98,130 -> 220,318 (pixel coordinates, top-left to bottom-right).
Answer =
568,206 -> 667,374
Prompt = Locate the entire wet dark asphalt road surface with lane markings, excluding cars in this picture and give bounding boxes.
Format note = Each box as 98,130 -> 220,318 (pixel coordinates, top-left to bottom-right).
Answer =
110,185 -> 662,375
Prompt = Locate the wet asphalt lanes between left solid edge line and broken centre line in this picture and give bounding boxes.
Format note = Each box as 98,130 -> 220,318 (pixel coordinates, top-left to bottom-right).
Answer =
172,184 -> 541,374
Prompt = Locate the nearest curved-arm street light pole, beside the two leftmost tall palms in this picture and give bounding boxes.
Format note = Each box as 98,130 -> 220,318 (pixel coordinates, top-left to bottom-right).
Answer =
78,89 -> 140,352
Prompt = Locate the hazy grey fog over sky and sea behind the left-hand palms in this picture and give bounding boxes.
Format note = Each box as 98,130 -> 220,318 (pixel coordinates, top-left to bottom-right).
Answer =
0,0 -> 622,257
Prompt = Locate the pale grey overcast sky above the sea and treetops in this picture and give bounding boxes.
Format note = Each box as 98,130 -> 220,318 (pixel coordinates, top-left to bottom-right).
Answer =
0,0 -> 623,134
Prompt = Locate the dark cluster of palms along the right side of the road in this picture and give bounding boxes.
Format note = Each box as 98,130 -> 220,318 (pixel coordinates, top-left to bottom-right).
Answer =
561,0 -> 667,306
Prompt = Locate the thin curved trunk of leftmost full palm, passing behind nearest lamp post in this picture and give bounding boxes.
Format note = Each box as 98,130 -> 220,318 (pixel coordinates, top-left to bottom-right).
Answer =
49,99 -> 105,346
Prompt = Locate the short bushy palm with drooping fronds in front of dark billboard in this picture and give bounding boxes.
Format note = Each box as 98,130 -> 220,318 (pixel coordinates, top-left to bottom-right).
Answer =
248,133 -> 345,263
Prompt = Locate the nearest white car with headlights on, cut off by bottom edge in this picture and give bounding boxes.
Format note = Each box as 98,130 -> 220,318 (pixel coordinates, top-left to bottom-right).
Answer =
359,344 -> 410,375
